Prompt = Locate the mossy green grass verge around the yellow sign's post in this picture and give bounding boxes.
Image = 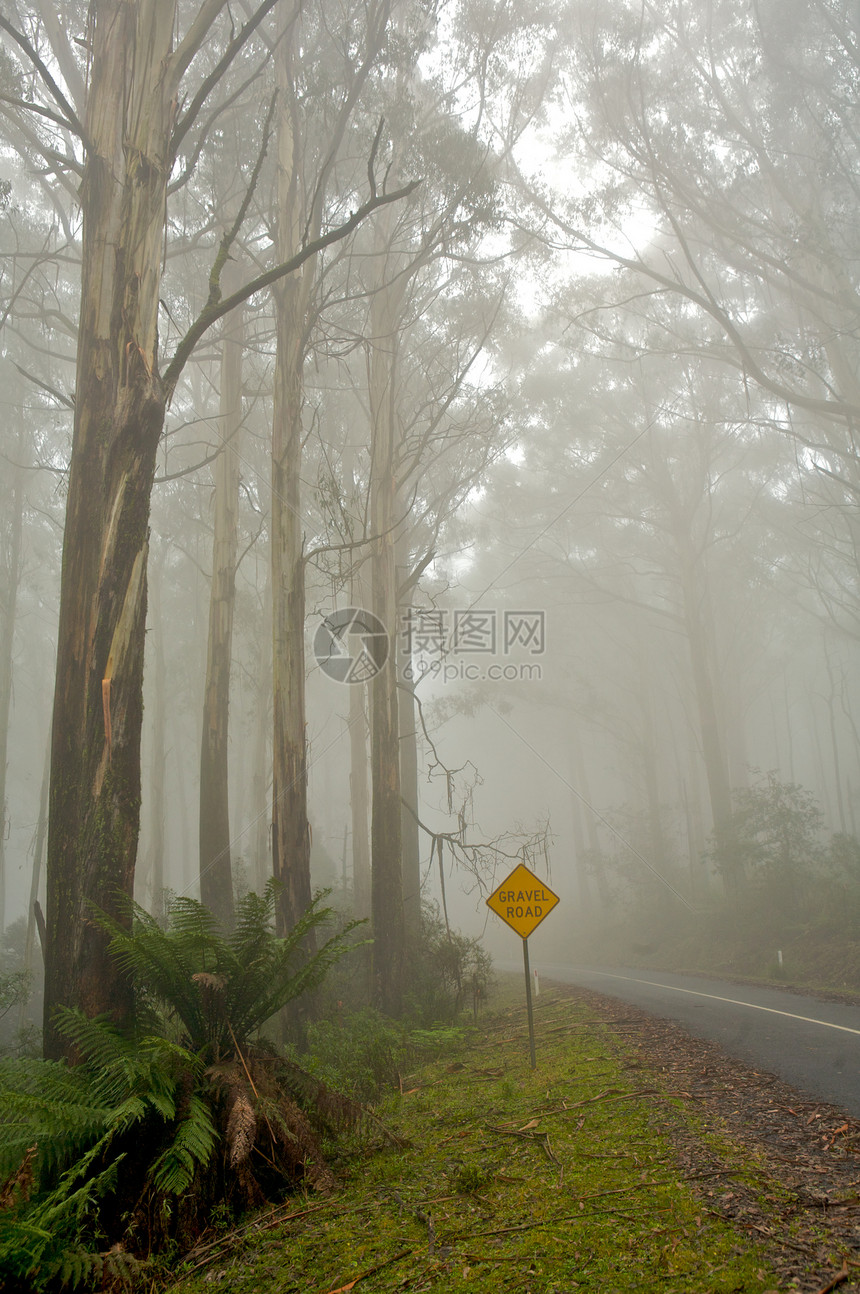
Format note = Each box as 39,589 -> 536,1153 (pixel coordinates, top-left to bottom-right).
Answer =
165,995 -> 777,1294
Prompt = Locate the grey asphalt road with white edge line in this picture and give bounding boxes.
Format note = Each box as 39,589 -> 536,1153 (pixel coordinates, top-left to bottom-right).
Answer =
533,963 -> 860,1118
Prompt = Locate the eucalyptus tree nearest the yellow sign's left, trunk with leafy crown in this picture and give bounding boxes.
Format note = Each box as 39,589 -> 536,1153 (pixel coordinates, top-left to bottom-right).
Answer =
325,179 -> 517,1012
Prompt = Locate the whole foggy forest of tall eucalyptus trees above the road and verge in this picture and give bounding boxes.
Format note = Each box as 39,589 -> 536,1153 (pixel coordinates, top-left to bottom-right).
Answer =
0,0 -> 860,1289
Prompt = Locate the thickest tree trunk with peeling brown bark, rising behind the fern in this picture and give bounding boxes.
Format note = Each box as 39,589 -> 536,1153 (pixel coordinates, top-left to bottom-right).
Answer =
44,0 -> 189,1057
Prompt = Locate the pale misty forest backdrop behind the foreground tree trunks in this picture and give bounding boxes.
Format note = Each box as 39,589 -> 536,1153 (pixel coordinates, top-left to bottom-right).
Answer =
0,0 -> 860,981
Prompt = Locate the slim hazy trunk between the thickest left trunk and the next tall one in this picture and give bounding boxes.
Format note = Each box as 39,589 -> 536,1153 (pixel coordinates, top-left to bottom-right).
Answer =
199,287 -> 243,929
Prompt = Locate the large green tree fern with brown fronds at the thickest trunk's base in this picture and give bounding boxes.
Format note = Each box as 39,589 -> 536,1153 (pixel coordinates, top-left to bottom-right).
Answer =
0,883 -> 358,1288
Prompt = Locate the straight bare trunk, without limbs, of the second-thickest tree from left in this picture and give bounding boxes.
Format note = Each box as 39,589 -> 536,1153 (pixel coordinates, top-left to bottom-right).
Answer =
272,25 -> 314,934
